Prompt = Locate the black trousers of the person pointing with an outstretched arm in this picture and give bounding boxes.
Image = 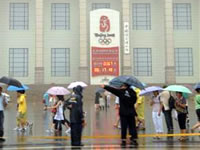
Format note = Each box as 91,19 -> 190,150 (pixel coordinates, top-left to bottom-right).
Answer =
120,116 -> 138,140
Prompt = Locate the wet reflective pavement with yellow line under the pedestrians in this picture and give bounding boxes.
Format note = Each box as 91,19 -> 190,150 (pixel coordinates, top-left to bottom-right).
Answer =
0,86 -> 200,150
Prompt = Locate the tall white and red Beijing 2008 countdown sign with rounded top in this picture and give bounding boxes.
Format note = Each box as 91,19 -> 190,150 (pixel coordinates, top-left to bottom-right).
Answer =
90,9 -> 120,84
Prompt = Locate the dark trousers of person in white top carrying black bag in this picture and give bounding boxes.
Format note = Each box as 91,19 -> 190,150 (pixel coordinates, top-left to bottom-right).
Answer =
163,110 -> 174,133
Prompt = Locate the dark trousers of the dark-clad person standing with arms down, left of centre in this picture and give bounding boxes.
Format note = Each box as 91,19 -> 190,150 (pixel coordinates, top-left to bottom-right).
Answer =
71,123 -> 82,146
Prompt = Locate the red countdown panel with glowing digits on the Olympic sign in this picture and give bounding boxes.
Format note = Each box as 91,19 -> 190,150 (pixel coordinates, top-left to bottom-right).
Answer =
92,47 -> 119,76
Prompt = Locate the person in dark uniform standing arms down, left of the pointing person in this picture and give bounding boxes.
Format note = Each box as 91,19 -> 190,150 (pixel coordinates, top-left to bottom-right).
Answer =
66,86 -> 84,146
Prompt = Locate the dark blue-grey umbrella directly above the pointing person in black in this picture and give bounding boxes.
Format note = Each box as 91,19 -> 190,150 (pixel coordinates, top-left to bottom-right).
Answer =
109,75 -> 144,89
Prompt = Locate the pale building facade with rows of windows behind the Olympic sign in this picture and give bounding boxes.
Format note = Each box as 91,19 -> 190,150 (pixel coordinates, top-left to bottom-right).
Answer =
0,0 -> 200,84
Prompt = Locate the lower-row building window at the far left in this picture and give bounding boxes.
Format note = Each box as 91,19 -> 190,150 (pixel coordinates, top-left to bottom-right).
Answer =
9,48 -> 28,77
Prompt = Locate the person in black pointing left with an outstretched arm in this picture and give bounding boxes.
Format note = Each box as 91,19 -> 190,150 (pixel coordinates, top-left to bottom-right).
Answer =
102,84 -> 138,146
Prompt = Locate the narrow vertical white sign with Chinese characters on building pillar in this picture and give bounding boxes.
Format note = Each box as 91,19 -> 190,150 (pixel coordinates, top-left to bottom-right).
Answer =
124,22 -> 130,54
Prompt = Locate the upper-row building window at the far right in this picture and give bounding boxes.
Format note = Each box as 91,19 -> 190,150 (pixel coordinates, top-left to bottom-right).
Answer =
173,3 -> 192,30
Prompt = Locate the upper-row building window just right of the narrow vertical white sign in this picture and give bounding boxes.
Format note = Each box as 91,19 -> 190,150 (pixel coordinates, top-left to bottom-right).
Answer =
132,3 -> 151,30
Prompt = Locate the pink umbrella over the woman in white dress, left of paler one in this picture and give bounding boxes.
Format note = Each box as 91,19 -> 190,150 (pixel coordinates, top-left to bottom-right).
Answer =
47,86 -> 70,95
